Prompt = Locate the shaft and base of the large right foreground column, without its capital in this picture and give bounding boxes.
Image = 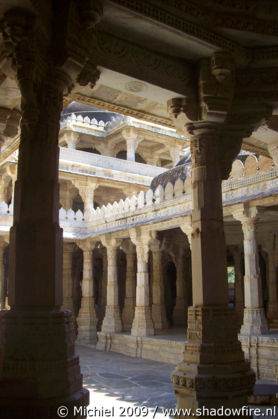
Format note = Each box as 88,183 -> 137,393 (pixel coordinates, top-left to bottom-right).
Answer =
172,127 -> 254,409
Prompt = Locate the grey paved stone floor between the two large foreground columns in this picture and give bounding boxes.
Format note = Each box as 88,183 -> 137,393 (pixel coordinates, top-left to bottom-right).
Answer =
77,345 -> 278,419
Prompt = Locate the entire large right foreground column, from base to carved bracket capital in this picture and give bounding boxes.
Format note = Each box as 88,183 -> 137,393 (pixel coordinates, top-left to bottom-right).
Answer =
168,51 -> 255,410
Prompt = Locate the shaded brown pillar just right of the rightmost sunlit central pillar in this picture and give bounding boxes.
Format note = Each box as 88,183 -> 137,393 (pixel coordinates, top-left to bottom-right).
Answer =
150,239 -> 168,330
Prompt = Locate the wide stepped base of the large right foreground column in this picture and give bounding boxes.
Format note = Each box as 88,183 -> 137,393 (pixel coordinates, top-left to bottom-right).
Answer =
172,307 -> 255,418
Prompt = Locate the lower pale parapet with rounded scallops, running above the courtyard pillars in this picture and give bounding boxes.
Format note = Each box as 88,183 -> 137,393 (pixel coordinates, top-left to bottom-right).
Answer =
0,169 -> 278,238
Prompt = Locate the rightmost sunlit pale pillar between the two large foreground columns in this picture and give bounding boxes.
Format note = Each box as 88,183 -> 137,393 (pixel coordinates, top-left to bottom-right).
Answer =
130,230 -> 154,336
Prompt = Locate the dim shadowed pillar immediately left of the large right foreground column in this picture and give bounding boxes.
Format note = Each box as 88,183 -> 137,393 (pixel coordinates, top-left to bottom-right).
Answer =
173,247 -> 187,326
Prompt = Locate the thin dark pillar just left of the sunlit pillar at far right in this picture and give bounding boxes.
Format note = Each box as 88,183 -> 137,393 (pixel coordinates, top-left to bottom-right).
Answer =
230,246 -> 244,326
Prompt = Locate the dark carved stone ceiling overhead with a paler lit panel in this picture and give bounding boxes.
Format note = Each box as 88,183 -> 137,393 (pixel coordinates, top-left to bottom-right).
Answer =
0,0 -> 278,160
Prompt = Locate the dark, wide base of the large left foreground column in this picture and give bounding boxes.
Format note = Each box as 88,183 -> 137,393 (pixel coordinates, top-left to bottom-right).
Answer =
0,310 -> 89,419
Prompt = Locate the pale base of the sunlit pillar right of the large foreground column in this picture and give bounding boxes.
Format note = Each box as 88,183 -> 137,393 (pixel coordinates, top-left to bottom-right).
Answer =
240,308 -> 269,336
